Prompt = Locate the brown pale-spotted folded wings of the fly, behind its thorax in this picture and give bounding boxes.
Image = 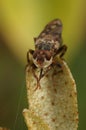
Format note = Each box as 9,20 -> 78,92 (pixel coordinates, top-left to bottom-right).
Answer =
35,19 -> 62,43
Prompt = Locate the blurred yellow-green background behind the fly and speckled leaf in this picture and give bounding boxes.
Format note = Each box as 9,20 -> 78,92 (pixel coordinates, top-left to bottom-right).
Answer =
0,0 -> 86,130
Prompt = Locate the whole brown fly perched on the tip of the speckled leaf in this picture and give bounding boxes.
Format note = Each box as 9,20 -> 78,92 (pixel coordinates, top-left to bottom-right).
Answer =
27,19 -> 67,89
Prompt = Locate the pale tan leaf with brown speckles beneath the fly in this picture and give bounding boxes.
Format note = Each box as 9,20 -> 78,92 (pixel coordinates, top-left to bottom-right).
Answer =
23,59 -> 78,130
